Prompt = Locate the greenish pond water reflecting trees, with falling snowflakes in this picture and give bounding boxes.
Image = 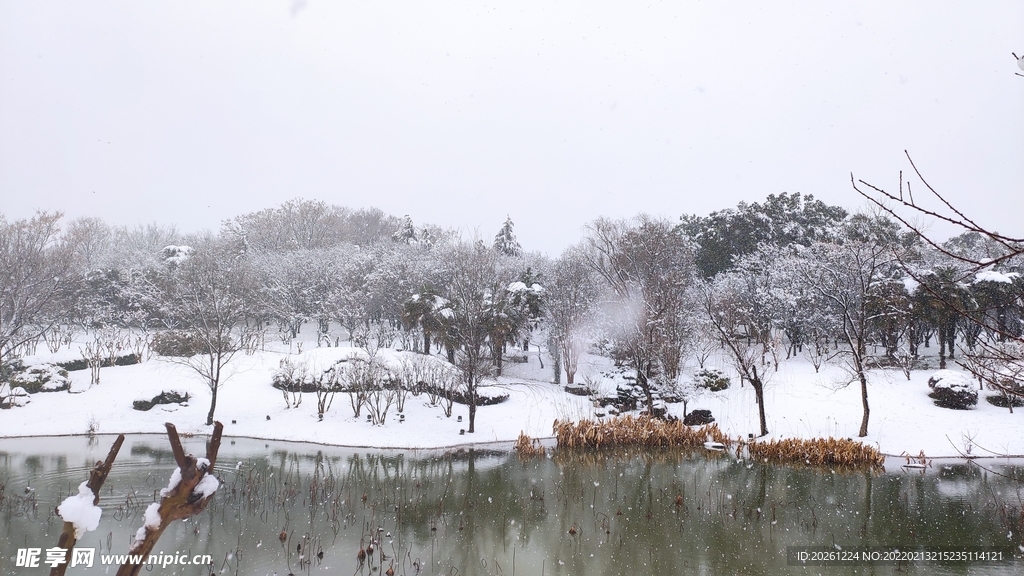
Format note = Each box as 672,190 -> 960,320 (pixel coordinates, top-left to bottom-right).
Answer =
0,435 -> 1024,576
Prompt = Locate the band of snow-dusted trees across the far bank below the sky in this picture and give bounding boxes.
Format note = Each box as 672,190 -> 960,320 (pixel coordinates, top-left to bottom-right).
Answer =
0,194 -> 1024,436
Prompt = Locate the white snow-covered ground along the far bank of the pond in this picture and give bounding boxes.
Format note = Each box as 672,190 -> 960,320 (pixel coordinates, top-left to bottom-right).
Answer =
0,332 -> 1024,457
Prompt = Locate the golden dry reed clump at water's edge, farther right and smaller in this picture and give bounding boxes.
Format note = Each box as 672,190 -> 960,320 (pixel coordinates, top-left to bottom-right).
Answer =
746,438 -> 885,467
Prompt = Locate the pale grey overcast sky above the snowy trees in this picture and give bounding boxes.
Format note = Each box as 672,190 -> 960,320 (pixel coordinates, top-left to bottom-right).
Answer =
0,0 -> 1024,254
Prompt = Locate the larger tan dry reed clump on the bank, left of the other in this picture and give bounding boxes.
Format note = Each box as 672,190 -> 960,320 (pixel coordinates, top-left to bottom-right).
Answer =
552,416 -> 732,448
